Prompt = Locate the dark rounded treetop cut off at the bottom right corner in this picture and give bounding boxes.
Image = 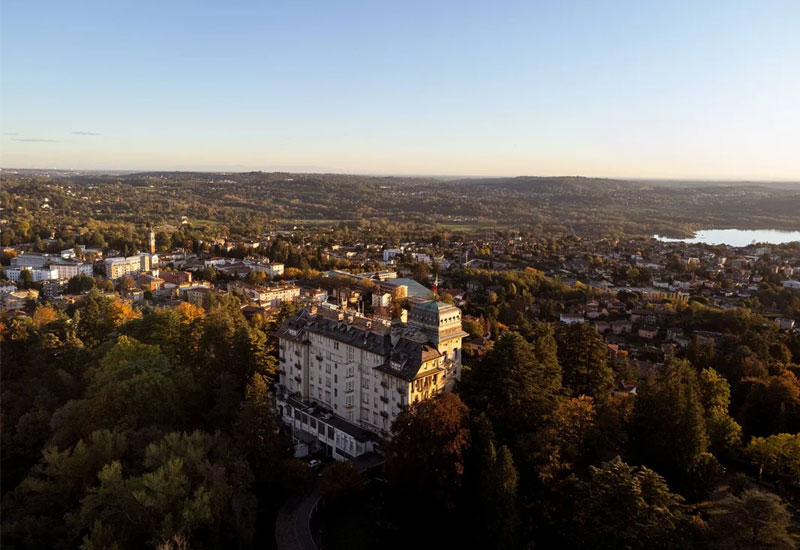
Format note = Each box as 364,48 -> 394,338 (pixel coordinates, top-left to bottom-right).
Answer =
708,489 -> 795,550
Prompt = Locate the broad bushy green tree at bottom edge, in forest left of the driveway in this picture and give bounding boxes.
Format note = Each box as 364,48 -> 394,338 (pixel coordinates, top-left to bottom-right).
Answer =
70,431 -> 255,547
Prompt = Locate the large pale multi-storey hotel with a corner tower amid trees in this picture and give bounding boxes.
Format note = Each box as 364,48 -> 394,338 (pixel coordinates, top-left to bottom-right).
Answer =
276,301 -> 466,459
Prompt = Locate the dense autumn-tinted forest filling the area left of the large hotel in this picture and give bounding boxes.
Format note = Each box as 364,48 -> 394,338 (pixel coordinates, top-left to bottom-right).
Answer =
0,298 -> 309,549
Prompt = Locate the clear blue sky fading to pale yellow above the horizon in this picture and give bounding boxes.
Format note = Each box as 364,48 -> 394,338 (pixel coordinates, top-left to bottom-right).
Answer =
0,0 -> 800,179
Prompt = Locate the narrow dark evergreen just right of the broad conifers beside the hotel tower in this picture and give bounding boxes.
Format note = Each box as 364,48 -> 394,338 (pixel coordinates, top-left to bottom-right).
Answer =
556,323 -> 614,399
